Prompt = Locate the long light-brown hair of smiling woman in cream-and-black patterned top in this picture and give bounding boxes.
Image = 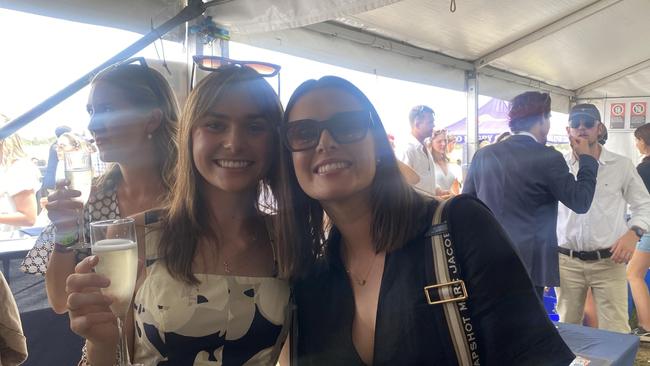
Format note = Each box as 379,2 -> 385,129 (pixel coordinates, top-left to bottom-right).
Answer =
158,66 -> 282,285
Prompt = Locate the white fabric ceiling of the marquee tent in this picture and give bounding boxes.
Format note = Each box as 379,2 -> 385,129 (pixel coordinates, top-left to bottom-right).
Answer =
0,0 -> 650,105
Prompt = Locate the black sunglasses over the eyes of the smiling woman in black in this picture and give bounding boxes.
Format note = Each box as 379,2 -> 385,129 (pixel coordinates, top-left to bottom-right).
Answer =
280,111 -> 373,152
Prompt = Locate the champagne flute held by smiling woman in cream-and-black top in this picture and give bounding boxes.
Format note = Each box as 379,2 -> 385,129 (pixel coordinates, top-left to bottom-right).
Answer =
90,218 -> 138,366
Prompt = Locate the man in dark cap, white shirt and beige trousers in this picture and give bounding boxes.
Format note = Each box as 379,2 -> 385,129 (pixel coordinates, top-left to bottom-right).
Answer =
556,104 -> 650,333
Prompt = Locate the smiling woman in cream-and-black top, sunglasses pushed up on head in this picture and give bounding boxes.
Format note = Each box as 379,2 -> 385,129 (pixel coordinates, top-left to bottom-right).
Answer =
68,66 -> 289,366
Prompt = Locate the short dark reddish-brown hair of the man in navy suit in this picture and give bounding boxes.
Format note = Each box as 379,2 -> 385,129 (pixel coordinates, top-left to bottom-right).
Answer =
508,91 -> 551,132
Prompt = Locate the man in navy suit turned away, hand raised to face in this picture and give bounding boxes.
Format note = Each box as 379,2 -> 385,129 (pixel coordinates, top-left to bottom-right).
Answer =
463,92 -> 598,299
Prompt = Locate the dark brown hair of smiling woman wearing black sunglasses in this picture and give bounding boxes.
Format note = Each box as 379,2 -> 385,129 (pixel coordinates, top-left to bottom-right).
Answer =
277,76 -> 427,278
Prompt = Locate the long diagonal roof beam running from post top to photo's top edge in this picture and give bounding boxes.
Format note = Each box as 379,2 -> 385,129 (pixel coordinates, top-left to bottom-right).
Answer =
474,0 -> 623,69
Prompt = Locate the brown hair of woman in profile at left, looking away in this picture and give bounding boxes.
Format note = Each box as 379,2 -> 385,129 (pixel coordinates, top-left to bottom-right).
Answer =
92,64 -> 178,197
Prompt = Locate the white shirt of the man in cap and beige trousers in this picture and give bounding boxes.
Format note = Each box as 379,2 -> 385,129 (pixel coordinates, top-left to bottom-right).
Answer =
557,147 -> 650,251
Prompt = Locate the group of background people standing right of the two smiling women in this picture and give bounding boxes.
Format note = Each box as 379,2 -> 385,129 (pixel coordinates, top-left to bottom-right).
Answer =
394,92 -> 650,340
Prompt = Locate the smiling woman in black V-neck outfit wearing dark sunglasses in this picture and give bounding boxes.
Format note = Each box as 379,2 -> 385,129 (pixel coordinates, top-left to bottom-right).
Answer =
278,76 -> 573,365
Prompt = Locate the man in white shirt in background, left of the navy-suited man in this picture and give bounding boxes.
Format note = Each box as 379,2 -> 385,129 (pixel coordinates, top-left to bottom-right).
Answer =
395,105 -> 437,196
